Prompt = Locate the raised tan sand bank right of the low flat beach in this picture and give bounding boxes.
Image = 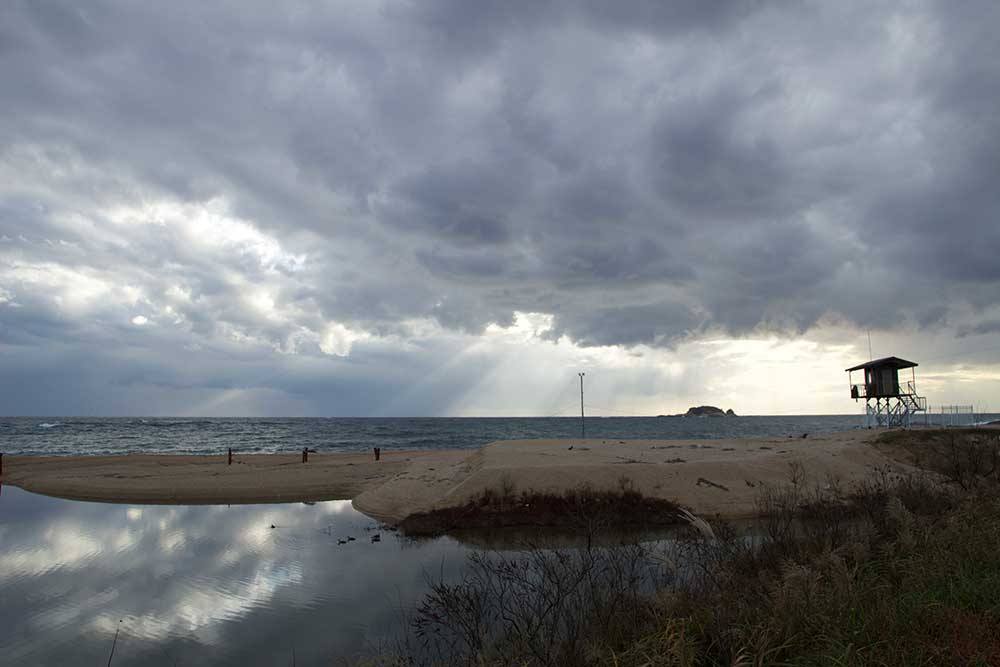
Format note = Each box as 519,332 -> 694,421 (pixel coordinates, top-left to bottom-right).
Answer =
354,431 -> 913,521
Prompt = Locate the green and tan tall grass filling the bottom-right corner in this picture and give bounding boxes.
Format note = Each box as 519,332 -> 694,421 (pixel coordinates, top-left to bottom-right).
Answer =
624,498 -> 1000,667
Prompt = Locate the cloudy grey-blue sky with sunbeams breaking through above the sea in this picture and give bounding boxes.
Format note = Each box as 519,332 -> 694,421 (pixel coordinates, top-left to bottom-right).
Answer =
0,0 -> 1000,416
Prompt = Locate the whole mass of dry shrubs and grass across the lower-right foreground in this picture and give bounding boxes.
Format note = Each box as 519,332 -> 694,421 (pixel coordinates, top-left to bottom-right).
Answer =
372,431 -> 1000,667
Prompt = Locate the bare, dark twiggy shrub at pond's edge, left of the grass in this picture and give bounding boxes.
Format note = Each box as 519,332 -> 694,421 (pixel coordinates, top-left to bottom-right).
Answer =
414,544 -> 668,665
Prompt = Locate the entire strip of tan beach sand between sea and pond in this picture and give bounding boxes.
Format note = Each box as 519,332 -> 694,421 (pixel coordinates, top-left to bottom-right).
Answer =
2,431 -> 913,522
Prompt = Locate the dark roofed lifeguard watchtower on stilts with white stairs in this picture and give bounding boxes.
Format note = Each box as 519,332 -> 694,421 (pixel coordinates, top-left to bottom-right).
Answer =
847,357 -> 927,428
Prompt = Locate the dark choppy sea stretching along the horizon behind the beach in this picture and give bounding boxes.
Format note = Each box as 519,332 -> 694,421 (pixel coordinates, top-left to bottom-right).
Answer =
0,415 -> 880,455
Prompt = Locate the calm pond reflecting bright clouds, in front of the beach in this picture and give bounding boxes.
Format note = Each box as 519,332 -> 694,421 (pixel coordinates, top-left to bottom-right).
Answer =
0,486 -> 473,666
